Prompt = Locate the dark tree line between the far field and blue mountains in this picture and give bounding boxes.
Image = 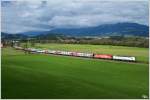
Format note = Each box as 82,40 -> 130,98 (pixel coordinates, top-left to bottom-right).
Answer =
2,36 -> 149,48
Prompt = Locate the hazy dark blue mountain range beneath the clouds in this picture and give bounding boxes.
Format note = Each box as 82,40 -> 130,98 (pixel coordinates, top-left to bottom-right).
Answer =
2,23 -> 149,37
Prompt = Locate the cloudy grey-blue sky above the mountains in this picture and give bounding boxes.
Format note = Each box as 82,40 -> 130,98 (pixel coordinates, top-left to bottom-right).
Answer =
1,0 -> 149,34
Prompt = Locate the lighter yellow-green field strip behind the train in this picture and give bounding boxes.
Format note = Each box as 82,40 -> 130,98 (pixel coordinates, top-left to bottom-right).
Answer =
31,44 -> 149,63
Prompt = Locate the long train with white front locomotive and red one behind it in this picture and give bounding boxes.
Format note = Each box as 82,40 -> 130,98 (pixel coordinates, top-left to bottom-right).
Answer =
14,46 -> 136,62
